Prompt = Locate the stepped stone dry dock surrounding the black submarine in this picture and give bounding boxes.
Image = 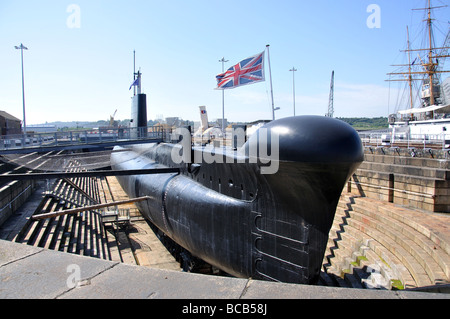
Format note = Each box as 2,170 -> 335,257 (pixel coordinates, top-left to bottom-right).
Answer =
0,148 -> 450,299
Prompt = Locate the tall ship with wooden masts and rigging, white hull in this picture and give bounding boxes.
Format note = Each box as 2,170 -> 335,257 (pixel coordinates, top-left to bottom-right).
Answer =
387,0 -> 450,144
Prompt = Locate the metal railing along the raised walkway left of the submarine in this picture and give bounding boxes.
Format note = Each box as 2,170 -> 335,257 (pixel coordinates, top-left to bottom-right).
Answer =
0,126 -> 168,150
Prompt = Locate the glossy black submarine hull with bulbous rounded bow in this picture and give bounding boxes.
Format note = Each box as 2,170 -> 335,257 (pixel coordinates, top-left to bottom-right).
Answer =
111,116 -> 363,284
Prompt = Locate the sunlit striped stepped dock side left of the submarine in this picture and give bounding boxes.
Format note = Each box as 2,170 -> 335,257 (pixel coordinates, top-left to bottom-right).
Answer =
11,163 -> 114,260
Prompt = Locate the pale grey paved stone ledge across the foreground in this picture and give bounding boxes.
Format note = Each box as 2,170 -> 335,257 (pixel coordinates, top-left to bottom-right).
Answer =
0,241 -> 450,300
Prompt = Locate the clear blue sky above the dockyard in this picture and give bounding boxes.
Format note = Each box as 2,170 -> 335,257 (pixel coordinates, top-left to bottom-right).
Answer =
0,0 -> 450,124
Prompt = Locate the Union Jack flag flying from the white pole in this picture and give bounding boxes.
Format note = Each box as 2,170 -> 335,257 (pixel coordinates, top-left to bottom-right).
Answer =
216,51 -> 264,90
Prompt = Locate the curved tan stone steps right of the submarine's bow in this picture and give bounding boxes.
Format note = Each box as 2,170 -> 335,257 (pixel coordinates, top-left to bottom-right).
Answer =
320,192 -> 450,289
